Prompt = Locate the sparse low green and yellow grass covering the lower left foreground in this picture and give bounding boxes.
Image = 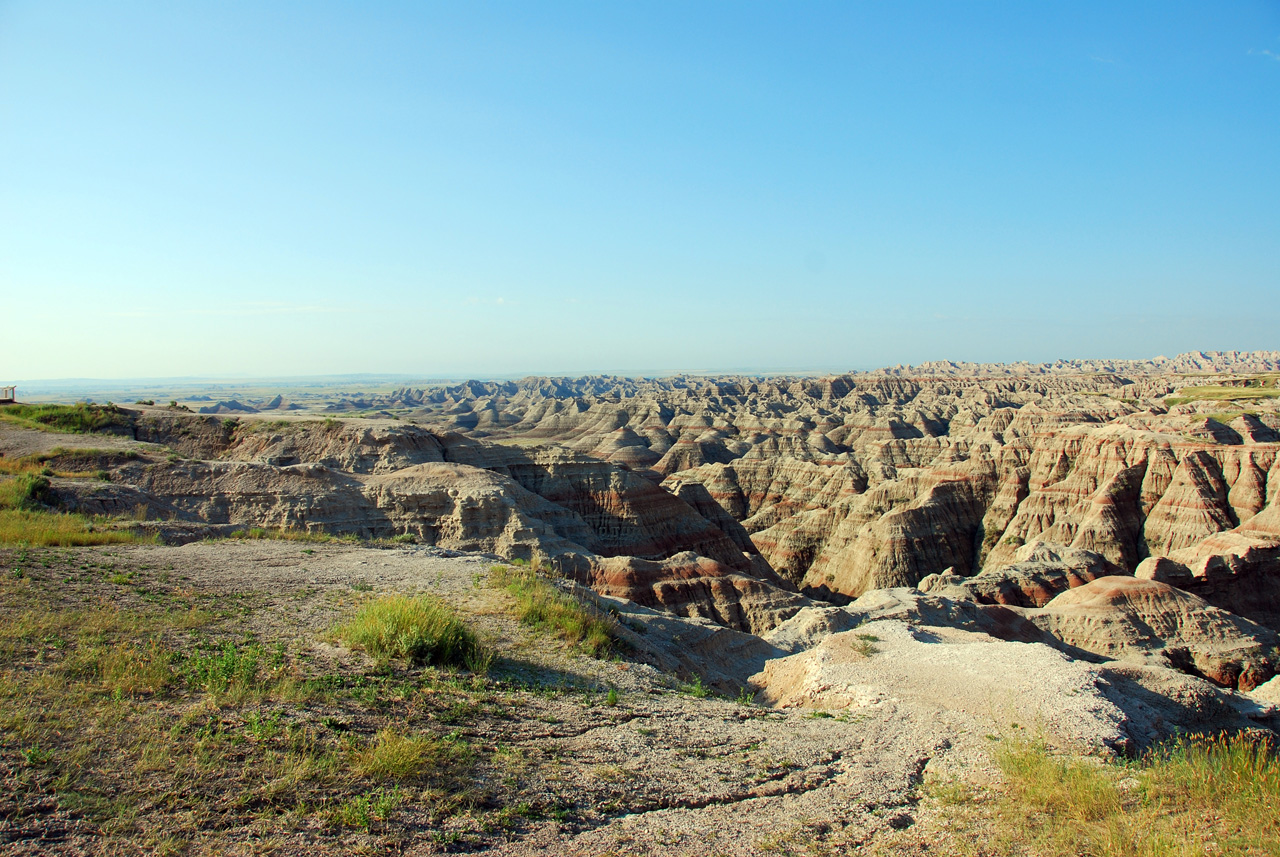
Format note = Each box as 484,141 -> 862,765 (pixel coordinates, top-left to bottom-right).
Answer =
0,551 -> 500,853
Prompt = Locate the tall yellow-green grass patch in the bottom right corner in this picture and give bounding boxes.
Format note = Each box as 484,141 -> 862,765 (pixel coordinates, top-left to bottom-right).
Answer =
934,734 -> 1280,857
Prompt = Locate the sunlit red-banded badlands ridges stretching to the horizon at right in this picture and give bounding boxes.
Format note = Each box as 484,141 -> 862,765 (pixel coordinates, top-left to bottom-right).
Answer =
360,352 -> 1280,636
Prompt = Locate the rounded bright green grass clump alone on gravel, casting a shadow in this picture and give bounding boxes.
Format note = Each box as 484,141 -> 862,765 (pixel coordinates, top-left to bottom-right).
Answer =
338,595 -> 493,674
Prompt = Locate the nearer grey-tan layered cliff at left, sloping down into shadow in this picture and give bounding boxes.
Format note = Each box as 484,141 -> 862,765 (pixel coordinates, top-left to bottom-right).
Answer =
52,413 -> 808,632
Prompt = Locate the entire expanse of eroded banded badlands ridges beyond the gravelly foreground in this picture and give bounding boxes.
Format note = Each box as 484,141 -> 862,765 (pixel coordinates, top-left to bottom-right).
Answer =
17,352 -> 1280,700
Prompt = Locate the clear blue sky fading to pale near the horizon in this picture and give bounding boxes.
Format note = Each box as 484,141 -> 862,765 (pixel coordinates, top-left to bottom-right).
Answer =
0,0 -> 1280,381
